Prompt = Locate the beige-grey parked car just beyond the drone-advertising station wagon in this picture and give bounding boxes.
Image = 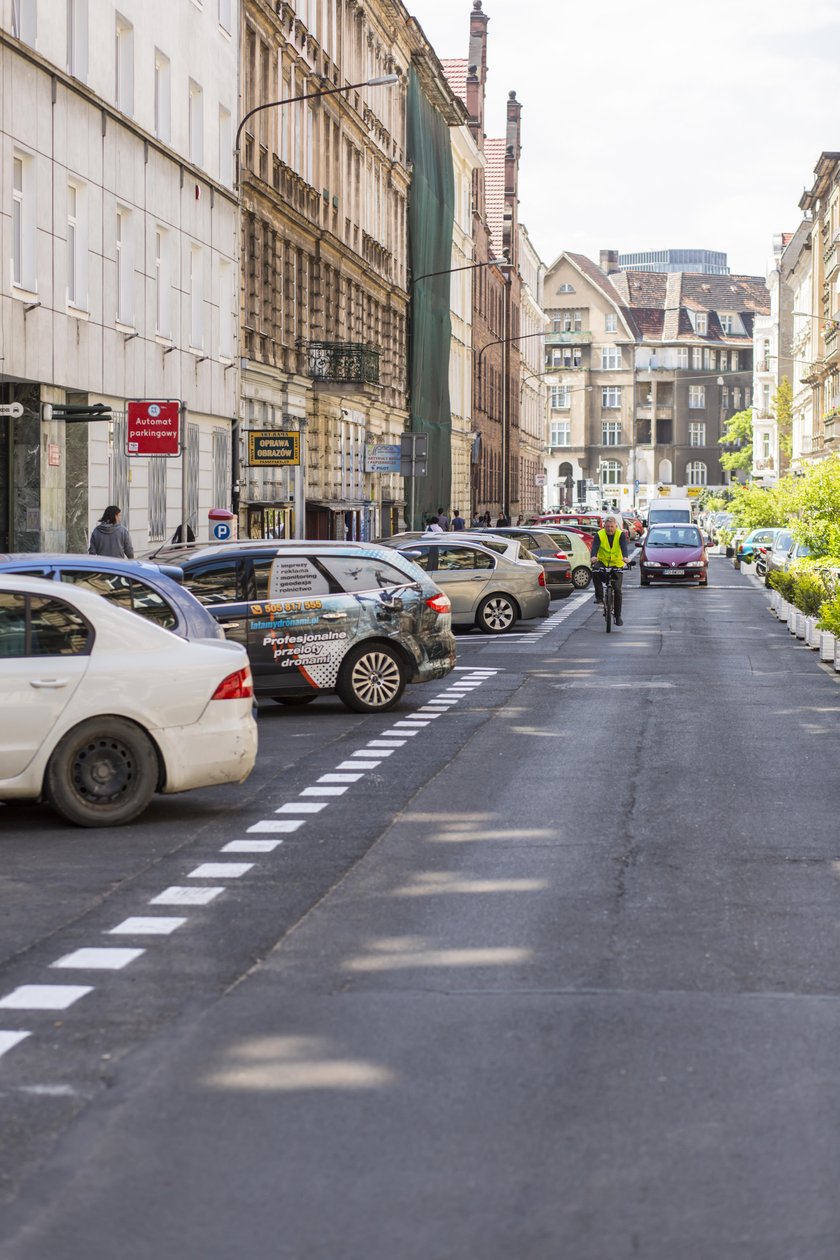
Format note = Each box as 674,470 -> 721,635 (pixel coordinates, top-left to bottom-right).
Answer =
385,534 -> 549,634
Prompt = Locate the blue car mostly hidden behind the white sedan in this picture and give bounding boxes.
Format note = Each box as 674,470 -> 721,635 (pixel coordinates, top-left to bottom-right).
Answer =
0,552 -> 224,639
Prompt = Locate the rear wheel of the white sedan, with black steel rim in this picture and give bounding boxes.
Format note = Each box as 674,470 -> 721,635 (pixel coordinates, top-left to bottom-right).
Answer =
44,717 -> 159,827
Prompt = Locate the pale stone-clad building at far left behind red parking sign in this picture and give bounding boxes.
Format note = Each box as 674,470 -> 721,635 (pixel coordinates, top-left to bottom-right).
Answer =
0,0 -> 238,551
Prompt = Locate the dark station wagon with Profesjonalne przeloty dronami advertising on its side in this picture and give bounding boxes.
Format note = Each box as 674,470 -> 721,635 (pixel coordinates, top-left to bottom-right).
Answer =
145,539 -> 455,713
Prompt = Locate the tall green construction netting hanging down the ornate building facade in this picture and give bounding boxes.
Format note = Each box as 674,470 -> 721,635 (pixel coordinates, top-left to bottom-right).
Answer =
406,71 -> 453,528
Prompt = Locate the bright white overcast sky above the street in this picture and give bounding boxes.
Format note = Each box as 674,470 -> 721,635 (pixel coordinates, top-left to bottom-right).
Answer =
406,0 -> 840,275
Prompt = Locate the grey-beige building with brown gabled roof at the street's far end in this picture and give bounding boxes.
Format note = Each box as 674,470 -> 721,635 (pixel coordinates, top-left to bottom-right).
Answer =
545,251 -> 769,507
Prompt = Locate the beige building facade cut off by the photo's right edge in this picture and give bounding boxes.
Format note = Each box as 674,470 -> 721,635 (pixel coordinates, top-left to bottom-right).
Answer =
796,152 -> 840,464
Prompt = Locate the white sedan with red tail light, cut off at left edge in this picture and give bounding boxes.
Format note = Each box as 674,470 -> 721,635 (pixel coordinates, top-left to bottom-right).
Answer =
0,573 -> 257,827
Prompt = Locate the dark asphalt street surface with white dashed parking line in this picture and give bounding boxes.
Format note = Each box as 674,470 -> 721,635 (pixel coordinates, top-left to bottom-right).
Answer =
0,559 -> 840,1260
